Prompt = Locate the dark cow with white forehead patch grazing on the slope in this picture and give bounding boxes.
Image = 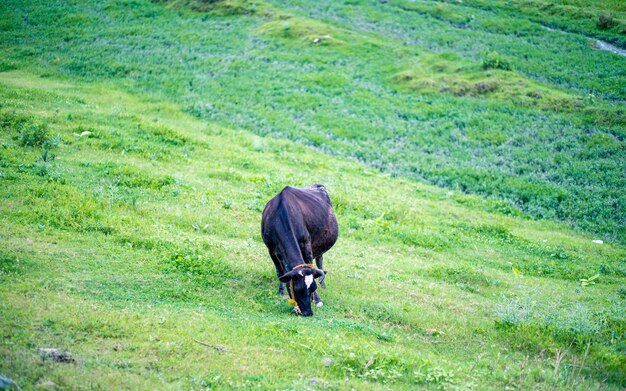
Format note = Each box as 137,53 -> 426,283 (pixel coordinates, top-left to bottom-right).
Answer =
261,184 -> 339,316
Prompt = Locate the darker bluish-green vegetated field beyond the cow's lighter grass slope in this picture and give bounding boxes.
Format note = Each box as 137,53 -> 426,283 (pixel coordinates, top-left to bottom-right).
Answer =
0,1 -> 626,243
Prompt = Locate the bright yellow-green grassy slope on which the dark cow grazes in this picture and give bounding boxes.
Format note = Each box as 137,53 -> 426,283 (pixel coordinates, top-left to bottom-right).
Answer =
0,72 -> 626,389
